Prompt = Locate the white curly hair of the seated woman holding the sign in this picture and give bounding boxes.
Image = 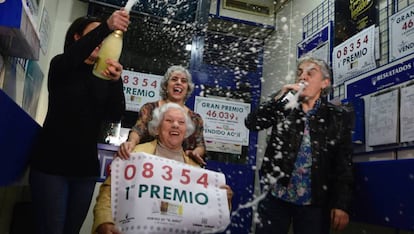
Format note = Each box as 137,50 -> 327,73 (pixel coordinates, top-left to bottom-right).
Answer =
148,102 -> 195,138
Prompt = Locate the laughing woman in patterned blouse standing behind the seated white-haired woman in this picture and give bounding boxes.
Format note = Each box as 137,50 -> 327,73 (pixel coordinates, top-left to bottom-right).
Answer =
117,66 -> 205,165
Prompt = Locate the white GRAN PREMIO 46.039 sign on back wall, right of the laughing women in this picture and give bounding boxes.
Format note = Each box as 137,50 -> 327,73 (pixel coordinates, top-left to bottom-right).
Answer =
194,96 -> 250,145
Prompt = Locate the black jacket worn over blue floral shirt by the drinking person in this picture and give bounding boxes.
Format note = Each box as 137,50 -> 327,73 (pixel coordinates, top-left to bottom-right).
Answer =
245,94 -> 354,213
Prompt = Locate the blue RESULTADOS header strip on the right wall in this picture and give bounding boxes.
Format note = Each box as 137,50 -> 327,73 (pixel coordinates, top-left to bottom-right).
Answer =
346,58 -> 414,99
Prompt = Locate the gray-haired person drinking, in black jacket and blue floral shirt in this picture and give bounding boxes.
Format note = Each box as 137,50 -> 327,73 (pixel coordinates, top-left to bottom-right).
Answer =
245,57 -> 354,234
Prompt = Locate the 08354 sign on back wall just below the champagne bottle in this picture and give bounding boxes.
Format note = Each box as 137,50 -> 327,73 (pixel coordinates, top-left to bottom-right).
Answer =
122,70 -> 162,112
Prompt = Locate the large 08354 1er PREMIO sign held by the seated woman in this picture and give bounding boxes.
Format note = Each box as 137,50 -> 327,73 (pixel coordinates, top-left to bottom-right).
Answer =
111,152 -> 230,234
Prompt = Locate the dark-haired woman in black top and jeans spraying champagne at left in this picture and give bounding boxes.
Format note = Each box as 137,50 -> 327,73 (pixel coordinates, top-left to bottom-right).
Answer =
30,9 -> 129,234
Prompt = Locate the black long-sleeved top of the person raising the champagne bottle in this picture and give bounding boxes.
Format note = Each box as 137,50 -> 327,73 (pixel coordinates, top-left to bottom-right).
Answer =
31,23 -> 125,177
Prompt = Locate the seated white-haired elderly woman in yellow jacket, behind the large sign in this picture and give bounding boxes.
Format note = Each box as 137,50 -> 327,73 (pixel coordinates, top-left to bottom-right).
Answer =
92,103 -> 233,234
